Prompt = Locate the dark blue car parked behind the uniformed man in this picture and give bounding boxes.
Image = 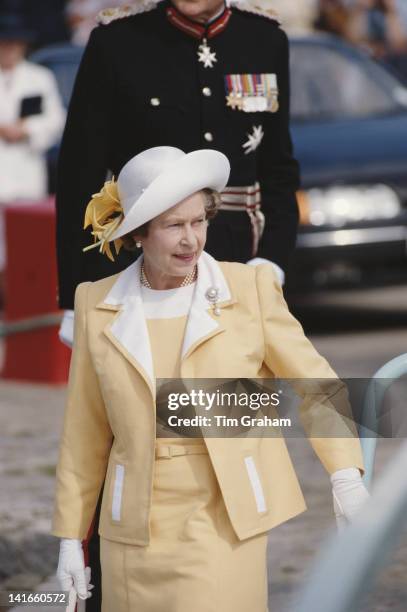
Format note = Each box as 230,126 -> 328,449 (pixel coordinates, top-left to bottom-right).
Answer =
32,35 -> 407,290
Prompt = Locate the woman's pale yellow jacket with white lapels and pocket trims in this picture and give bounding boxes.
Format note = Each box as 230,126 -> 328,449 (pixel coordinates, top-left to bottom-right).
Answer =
52,253 -> 363,545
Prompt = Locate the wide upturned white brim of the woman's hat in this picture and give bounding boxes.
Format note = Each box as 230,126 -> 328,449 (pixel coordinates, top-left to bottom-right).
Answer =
110,149 -> 230,241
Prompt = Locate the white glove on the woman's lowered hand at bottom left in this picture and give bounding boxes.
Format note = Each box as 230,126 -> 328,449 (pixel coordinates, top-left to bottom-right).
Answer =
57,538 -> 93,612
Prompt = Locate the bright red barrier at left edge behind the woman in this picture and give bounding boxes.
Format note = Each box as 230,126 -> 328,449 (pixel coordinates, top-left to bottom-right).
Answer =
2,198 -> 71,384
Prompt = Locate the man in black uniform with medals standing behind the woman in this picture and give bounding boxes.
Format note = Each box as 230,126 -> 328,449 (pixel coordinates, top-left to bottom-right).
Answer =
57,0 -> 299,610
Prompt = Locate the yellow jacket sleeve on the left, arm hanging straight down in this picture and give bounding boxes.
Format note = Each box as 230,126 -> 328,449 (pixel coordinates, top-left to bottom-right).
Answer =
52,283 -> 113,539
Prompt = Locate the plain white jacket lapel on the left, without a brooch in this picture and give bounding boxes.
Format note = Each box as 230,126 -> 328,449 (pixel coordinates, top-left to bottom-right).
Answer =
103,256 -> 155,395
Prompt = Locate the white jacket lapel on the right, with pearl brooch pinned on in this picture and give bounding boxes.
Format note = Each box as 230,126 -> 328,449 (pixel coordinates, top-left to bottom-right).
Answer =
181,251 -> 233,359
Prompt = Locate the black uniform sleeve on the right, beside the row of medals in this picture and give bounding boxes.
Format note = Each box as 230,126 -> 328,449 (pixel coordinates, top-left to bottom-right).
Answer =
257,29 -> 299,271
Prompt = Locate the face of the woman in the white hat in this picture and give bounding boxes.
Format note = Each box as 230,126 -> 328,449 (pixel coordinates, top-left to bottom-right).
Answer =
135,192 -> 208,289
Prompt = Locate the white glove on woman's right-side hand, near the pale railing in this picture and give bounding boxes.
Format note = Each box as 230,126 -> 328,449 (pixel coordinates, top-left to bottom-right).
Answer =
331,468 -> 370,531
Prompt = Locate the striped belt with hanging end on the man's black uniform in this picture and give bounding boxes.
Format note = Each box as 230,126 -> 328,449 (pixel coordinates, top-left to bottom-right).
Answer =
220,182 -> 265,257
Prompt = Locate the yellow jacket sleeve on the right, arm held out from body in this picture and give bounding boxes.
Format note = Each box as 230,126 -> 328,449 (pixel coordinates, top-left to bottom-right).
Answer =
256,264 -> 364,474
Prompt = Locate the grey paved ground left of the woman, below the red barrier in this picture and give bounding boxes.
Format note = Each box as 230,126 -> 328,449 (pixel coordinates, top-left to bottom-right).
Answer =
0,383 -> 65,609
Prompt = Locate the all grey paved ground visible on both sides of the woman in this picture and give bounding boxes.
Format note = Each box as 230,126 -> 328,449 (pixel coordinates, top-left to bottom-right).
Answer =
0,284 -> 407,612
